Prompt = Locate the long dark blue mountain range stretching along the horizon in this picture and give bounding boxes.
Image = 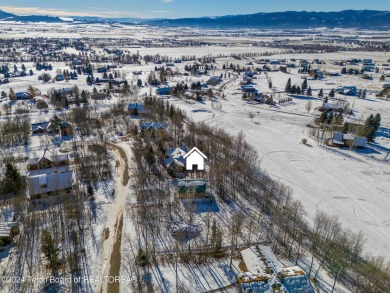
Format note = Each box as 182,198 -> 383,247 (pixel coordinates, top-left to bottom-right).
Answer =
0,10 -> 390,29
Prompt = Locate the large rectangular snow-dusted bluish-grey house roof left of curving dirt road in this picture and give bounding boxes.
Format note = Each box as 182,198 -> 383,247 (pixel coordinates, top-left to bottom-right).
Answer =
27,171 -> 73,196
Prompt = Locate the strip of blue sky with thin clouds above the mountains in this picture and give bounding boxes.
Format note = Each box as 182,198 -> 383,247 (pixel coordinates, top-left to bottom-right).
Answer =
0,0 -> 390,18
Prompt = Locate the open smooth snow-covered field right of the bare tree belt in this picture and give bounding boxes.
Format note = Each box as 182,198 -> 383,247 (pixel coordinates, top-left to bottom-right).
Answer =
169,88 -> 390,258
